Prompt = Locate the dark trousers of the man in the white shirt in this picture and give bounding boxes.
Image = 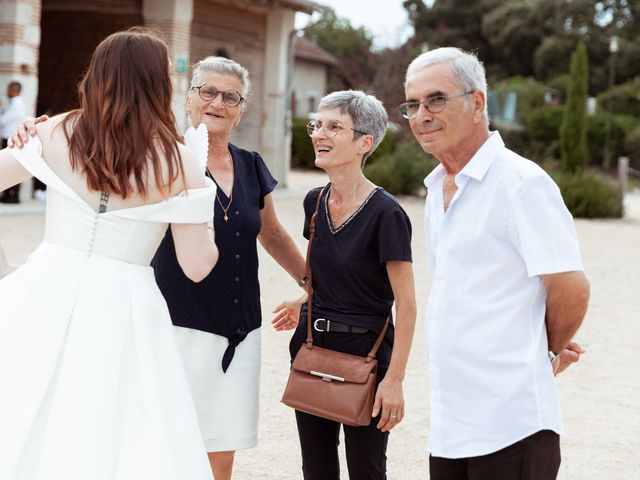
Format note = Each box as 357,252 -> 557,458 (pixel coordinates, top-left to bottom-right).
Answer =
429,430 -> 560,480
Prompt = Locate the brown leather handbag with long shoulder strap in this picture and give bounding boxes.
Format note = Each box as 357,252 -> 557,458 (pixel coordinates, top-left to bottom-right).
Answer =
282,190 -> 389,427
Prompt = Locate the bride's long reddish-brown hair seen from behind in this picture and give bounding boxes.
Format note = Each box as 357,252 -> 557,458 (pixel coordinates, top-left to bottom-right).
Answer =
63,28 -> 184,198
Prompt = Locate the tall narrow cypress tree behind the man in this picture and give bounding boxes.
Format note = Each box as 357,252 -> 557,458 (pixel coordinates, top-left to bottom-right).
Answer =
560,40 -> 589,173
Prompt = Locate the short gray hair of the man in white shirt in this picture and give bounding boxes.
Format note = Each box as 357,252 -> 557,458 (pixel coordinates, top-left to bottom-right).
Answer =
404,47 -> 489,125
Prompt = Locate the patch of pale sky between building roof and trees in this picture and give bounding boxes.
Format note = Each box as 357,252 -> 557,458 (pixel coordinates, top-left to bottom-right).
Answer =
296,0 -> 413,49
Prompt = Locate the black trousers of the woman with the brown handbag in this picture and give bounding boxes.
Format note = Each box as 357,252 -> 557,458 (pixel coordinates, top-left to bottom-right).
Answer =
289,322 -> 393,480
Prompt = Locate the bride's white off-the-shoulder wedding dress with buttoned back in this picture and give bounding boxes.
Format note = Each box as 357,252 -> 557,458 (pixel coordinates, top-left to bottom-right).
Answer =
0,138 -> 215,480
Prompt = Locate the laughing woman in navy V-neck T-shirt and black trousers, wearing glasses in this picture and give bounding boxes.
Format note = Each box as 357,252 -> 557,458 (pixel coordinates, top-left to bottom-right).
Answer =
272,91 -> 416,480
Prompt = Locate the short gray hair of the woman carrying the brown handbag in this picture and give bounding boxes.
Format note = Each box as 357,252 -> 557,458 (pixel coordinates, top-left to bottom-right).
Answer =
318,90 -> 389,165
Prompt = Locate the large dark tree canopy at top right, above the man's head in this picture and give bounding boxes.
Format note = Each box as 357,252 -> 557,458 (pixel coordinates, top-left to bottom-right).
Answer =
404,0 -> 640,94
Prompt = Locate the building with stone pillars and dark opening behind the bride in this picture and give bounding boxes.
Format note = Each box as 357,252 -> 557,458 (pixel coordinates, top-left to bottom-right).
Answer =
0,0 -> 320,184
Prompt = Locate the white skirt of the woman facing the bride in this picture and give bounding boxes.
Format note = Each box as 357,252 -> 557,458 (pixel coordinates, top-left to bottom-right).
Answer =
174,327 -> 261,452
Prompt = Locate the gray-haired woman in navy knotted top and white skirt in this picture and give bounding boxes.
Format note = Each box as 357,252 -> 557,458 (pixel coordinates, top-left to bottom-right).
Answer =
153,57 -> 304,480
